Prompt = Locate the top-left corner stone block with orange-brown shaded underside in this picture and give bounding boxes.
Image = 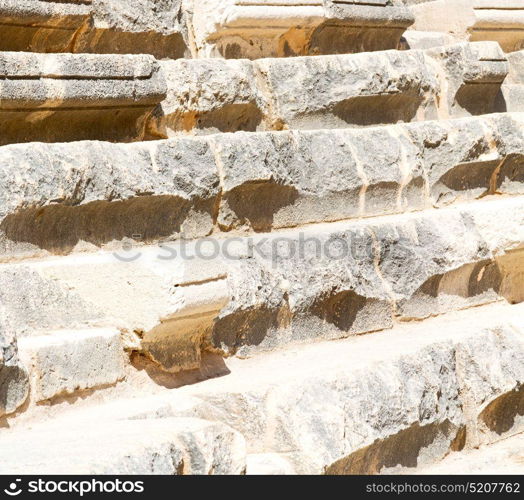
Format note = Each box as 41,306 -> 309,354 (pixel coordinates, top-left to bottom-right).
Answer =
0,0 -> 189,58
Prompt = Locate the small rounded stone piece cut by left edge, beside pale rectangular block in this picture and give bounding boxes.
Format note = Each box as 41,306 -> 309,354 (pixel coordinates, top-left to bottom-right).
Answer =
0,304 -> 29,417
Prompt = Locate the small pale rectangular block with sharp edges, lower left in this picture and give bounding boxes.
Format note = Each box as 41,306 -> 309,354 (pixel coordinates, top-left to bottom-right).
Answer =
19,329 -> 124,402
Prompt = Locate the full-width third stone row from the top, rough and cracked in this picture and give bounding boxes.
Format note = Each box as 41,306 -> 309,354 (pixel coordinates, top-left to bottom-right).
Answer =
0,114 -> 524,256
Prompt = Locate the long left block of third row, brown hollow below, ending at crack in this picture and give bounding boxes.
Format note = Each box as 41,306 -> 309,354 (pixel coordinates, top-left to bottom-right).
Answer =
0,139 -> 219,255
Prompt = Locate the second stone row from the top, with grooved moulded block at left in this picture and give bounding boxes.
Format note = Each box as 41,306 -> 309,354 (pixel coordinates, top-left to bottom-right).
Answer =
0,42 -> 522,145
